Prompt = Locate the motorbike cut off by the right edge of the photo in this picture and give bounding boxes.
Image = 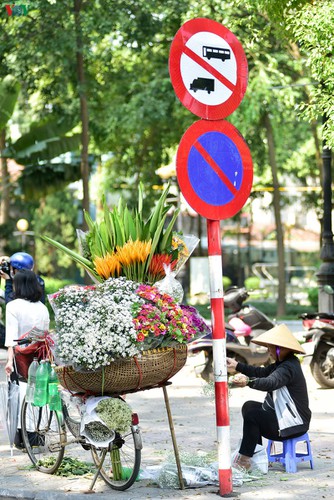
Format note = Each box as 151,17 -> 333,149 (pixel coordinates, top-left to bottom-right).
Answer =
299,313 -> 334,389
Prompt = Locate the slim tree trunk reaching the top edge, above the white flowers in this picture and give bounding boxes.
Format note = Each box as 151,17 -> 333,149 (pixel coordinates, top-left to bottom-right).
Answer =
74,0 -> 90,228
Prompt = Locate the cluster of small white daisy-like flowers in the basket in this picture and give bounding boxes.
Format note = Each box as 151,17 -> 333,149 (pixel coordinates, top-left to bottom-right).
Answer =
54,278 -> 143,370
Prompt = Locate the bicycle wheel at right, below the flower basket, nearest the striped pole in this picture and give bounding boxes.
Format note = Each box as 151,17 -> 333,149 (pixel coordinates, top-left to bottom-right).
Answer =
92,425 -> 142,491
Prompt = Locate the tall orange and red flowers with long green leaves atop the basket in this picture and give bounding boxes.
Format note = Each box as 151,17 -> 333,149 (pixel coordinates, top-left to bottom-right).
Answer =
42,185 -> 198,283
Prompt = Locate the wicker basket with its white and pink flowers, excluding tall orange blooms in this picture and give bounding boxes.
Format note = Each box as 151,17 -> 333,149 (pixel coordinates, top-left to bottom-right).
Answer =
49,277 -> 209,395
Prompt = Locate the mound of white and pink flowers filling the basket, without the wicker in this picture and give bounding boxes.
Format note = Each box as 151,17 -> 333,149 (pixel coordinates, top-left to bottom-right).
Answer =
49,277 -> 209,370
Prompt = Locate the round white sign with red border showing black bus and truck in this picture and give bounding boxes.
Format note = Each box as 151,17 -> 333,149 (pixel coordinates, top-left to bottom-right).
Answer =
169,18 -> 248,120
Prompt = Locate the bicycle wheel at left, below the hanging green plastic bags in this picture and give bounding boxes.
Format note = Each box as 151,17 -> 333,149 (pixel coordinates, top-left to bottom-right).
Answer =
21,401 -> 66,474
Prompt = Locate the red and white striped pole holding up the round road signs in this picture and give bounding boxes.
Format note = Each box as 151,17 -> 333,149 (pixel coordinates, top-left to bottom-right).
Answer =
207,219 -> 233,496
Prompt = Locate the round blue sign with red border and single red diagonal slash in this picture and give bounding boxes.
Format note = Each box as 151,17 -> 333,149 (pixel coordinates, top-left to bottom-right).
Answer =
176,120 -> 253,220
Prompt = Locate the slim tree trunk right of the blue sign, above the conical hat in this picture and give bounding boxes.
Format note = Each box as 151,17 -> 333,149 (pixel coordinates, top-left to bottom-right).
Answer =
264,112 -> 286,316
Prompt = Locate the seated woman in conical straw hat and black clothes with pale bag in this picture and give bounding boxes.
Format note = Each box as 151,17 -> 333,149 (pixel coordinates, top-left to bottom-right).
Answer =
226,324 -> 311,470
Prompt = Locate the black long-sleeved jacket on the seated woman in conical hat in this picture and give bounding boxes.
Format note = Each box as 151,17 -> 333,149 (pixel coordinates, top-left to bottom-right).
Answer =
236,354 -> 311,437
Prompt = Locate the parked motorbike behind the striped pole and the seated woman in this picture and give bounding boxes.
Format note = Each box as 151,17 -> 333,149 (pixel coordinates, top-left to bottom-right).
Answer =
188,287 -> 275,382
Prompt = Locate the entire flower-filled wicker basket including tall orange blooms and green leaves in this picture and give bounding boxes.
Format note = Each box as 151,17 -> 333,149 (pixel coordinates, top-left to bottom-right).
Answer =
44,186 -> 208,394
